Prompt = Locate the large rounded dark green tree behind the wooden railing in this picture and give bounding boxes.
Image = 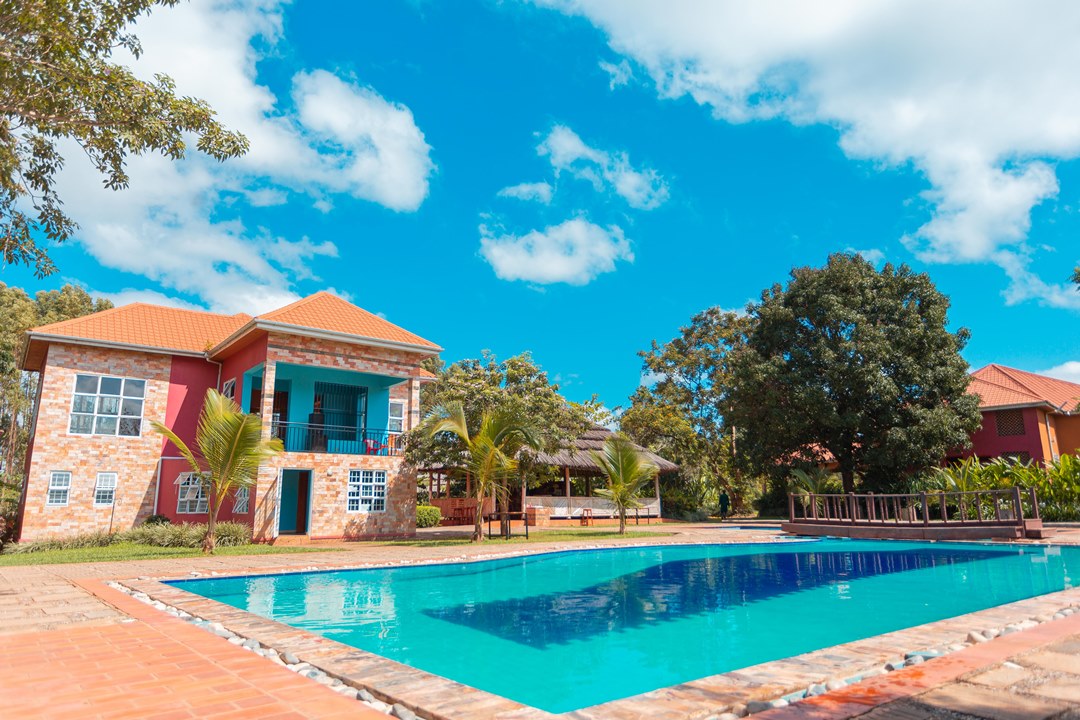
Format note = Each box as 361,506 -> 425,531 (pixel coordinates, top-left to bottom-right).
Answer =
727,254 -> 980,492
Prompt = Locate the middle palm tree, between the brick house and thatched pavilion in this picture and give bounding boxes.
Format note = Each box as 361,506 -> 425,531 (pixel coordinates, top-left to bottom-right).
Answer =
424,403 -> 540,543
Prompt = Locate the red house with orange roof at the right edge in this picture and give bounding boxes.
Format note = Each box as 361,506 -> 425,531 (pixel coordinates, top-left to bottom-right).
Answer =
961,365 -> 1080,463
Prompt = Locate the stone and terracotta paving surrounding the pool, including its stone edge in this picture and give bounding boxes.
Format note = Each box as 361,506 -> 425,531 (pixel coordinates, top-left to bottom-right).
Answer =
6,525 -> 1080,720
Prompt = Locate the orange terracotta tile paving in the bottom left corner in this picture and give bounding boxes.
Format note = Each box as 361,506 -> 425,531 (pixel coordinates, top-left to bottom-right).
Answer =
0,586 -> 387,720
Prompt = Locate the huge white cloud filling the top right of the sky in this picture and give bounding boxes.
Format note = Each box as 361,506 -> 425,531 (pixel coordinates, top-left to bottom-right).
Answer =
535,0 -> 1080,307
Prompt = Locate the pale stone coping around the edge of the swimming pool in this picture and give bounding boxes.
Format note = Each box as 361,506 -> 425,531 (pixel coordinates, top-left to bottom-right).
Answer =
105,535 -> 1080,720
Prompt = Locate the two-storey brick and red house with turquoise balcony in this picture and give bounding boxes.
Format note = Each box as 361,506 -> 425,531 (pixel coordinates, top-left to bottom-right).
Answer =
19,293 -> 441,541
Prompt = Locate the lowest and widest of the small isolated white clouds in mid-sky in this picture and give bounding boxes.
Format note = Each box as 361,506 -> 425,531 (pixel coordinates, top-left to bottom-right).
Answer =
480,218 -> 634,285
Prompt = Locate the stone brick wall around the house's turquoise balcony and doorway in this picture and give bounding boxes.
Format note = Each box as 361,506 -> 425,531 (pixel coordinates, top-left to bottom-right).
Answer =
254,332 -> 424,540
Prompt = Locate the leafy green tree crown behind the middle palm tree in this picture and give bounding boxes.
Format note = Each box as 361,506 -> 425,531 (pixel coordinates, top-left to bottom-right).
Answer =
405,352 -> 588,470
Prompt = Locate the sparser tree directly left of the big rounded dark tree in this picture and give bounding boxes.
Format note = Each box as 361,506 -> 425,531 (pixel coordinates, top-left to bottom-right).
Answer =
620,308 -> 751,506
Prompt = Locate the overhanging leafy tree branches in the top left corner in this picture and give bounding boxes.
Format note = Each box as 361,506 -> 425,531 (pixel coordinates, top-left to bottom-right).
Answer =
0,0 -> 247,276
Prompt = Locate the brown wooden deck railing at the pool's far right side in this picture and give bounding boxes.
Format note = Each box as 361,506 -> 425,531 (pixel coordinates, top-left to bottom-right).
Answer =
787,488 -> 1039,528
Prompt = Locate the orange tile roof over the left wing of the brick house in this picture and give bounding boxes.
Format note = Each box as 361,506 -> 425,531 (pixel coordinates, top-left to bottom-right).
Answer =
30,302 -> 252,353
